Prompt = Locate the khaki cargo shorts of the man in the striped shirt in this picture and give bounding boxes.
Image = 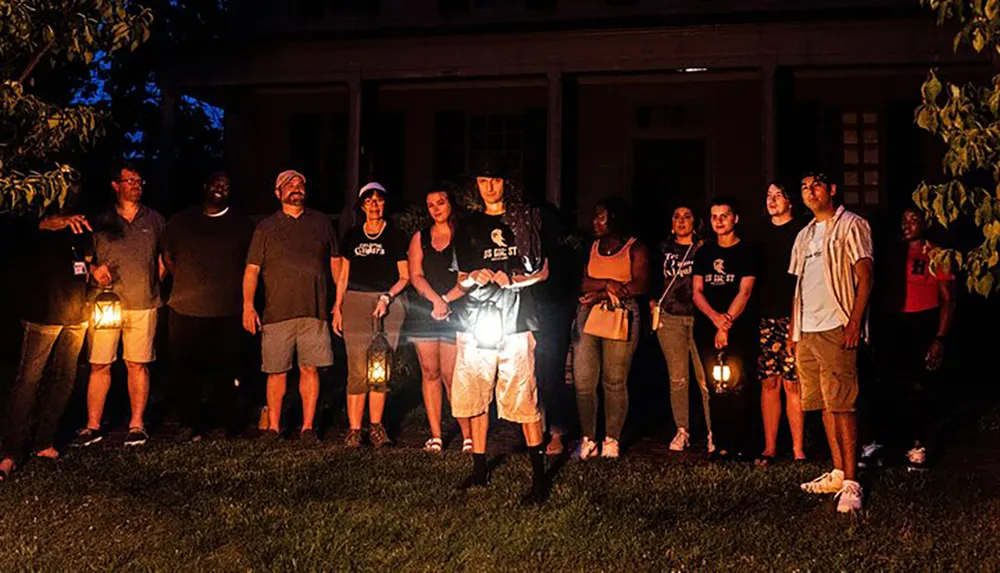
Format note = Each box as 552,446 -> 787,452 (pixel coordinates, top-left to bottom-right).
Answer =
795,327 -> 858,413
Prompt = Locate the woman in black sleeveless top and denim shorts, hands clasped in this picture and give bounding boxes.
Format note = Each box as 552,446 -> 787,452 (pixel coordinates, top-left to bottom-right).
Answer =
408,184 -> 472,453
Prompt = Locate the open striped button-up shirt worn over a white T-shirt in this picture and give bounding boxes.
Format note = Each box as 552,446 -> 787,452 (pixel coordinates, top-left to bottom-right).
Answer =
788,205 -> 875,342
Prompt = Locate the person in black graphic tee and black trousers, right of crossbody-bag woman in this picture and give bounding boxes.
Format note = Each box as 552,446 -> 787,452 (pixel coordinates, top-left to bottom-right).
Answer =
694,197 -> 757,460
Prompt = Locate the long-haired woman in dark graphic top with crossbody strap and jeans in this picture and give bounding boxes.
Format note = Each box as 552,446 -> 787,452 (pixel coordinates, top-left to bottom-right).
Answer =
650,205 -> 715,452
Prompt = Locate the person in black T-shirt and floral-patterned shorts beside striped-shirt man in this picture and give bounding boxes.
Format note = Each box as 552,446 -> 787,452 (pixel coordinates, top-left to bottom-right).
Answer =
756,183 -> 806,464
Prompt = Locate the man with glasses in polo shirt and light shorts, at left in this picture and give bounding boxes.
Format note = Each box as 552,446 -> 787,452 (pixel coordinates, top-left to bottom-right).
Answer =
72,162 -> 165,447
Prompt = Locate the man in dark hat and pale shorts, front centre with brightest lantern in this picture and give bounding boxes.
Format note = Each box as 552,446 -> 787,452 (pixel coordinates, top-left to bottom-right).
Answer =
451,156 -> 549,501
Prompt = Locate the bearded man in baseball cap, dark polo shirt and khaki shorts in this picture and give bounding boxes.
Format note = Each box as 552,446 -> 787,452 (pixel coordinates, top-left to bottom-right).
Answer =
243,170 -> 340,443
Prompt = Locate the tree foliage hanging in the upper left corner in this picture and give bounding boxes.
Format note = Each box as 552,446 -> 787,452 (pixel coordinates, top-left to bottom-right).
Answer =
0,0 -> 153,212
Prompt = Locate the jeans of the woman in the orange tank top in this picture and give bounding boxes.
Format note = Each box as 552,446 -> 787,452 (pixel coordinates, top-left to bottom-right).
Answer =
573,301 -> 641,440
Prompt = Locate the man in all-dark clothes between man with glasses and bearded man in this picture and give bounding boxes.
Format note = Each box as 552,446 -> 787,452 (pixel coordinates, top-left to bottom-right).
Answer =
163,172 -> 254,442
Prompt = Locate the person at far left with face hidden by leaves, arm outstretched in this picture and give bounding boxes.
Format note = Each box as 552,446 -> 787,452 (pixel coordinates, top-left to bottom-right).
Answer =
0,203 -> 92,482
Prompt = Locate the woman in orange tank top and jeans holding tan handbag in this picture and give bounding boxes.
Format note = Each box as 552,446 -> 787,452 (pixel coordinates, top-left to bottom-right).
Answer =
573,198 -> 649,460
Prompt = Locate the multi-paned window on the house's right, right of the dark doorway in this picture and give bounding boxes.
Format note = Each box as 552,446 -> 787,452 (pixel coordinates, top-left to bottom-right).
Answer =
841,110 -> 882,207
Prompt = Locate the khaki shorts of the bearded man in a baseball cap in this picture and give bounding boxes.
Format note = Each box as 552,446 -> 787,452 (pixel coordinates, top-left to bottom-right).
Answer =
260,317 -> 333,374
